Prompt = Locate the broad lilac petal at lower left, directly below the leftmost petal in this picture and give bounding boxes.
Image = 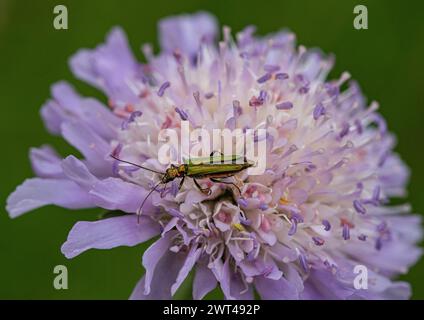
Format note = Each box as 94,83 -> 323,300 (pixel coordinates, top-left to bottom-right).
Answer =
61,215 -> 160,259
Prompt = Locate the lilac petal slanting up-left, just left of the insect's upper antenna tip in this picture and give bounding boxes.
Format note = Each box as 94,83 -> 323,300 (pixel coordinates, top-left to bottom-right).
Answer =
62,122 -> 112,175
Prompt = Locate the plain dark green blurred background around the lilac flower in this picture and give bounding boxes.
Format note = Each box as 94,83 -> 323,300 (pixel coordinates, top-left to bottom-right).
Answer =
0,0 -> 424,299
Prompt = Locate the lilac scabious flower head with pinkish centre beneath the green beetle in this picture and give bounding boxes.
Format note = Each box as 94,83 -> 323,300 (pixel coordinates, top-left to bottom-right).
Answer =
7,13 -> 421,299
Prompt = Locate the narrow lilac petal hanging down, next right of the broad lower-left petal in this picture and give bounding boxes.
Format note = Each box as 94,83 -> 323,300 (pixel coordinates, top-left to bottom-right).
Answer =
143,232 -> 175,295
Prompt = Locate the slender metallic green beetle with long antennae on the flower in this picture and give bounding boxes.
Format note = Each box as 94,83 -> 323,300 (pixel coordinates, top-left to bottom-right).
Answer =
111,152 -> 254,218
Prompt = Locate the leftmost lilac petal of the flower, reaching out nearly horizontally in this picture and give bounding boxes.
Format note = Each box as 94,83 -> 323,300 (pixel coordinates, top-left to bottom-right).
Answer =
6,178 -> 94,218
